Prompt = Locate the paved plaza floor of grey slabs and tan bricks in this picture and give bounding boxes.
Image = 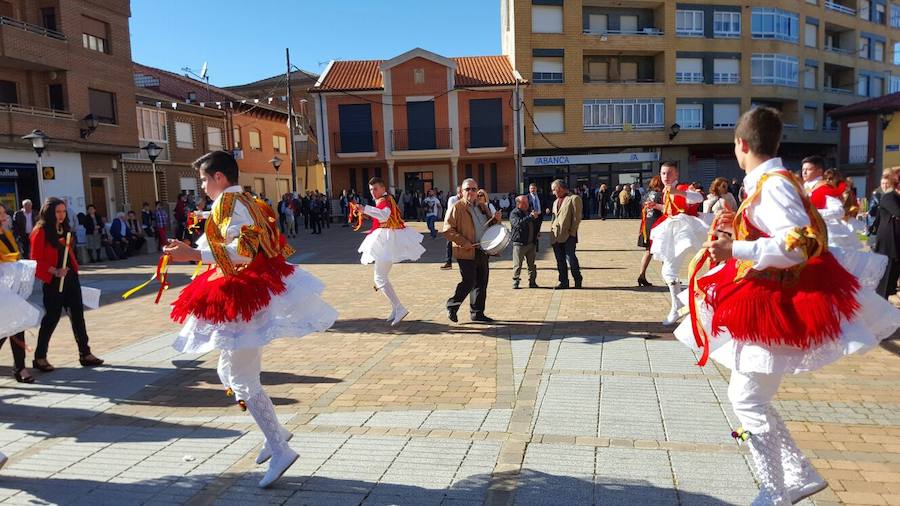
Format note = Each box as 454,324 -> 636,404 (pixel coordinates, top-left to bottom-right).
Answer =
0,220 -> 900,506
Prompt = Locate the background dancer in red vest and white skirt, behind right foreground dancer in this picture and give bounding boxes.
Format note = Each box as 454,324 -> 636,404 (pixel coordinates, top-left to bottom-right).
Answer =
646,162 -> 709,325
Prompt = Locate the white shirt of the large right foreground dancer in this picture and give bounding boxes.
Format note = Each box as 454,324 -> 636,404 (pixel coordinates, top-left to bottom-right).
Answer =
732,158 -> 809,270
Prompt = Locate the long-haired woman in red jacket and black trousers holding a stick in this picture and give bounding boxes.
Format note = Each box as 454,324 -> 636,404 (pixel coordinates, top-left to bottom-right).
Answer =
31,197 -> 103,372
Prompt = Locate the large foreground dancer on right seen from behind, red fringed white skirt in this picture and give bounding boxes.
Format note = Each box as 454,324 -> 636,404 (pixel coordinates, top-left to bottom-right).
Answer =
675,107 -> 900,506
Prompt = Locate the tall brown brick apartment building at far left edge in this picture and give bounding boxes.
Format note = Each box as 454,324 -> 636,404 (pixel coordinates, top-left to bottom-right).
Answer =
0,0 -> 137,216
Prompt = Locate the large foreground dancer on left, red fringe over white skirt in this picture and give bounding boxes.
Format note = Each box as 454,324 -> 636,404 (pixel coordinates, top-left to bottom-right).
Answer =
164,151 -> 337,487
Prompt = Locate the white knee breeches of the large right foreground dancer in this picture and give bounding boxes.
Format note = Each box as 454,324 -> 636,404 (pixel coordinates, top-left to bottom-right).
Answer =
728,371 -> 782,433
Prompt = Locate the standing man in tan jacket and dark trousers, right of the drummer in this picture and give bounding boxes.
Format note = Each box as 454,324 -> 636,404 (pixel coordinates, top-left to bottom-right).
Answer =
550,179 -> 583,289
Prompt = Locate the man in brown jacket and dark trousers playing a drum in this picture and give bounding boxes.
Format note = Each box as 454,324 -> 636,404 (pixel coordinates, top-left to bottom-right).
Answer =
443,178 -> 500,323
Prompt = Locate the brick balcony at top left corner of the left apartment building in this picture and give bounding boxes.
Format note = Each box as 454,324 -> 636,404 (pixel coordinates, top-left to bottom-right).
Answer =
0,16 -> 69,70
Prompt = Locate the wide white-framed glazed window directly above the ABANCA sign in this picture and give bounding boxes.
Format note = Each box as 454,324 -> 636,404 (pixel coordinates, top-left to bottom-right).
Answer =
584,98 -> 665,131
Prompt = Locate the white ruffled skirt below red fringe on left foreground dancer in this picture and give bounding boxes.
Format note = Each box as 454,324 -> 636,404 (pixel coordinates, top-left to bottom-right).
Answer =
172,266 -> 337,353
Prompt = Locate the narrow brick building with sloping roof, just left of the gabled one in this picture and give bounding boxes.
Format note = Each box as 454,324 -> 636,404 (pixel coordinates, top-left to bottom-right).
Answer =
225,70 -> 325,195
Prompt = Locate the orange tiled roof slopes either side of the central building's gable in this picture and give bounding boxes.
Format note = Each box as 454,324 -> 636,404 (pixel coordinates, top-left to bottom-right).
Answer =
310,56 -> 516,91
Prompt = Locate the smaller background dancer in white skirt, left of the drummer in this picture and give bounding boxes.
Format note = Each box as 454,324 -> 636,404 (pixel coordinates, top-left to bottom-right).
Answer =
350,177 -> 425,326
